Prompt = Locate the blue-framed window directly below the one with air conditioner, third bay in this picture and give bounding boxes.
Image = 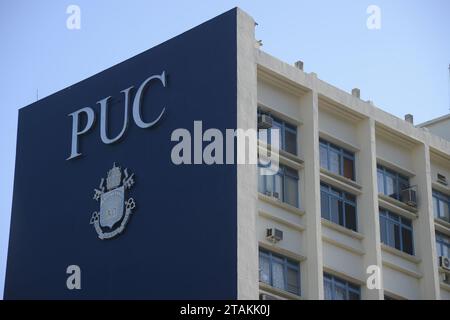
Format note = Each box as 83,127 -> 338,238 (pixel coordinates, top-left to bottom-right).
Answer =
380,209 -> 414,255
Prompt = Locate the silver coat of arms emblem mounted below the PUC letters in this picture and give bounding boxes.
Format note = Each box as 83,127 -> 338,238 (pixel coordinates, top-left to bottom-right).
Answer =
90,163 -> 136,240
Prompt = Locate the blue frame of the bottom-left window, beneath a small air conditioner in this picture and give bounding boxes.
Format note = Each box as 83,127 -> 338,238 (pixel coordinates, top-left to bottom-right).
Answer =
258,248 -> 302,296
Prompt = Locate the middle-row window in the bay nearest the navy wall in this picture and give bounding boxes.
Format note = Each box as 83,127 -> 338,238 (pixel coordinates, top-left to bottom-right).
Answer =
258,165 -> 299,208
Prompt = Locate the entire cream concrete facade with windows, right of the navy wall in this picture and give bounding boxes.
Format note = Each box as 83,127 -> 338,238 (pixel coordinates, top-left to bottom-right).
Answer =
230,9 -> 450,300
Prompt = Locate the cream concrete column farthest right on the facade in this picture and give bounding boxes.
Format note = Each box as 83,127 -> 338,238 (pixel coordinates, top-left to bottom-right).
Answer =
411,144 -> 440,300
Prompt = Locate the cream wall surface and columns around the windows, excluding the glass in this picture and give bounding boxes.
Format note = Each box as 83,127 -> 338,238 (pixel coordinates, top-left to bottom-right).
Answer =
246,17 -> 450,299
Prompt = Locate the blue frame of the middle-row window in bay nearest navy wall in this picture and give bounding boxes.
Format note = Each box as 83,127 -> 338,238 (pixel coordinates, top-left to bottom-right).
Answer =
258,164 -> 300,208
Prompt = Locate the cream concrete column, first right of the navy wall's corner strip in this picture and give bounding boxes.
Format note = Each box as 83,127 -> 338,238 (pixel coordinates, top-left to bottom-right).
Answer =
300,75 -> 324,300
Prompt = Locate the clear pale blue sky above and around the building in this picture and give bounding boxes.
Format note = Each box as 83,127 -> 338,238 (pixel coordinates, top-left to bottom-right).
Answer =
0,0 -> 450,297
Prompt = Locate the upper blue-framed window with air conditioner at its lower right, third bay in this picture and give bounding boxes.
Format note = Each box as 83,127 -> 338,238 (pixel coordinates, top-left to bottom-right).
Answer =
377,165 -> 409,201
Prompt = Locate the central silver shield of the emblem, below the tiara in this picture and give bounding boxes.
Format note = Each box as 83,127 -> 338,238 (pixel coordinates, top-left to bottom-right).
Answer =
99,186 -> 125,229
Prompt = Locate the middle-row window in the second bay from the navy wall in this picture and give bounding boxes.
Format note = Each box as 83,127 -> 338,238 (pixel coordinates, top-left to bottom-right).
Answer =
320,183 -> 358,231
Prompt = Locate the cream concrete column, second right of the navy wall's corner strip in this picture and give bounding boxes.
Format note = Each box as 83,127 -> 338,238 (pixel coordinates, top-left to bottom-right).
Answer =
356,118 -> 384,300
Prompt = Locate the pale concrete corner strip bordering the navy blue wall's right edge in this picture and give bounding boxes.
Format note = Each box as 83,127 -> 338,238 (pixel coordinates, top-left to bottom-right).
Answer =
234,9 -> 259,299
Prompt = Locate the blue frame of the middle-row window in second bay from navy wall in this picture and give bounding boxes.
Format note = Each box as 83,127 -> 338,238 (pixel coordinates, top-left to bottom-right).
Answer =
320,182 -> 359,232
